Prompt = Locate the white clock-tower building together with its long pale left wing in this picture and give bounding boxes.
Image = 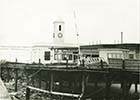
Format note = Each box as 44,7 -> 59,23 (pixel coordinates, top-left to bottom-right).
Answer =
0,20 -> 78,64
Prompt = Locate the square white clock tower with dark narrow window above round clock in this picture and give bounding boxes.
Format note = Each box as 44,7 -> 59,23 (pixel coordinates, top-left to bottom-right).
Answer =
53,20 -> 65,44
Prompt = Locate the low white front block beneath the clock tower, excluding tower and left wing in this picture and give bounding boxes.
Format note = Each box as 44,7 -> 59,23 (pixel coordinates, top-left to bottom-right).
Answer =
31,44 -> 77,64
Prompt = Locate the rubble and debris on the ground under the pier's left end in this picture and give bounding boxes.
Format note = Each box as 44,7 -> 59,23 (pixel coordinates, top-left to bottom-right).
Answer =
5,77 -> 50,100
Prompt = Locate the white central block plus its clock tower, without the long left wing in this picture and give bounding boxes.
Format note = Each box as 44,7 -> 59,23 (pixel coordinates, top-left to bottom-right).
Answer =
31,20 -> 78,64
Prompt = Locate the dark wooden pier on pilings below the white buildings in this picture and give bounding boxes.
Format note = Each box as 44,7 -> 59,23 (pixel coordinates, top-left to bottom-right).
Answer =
1,60 -> 140,100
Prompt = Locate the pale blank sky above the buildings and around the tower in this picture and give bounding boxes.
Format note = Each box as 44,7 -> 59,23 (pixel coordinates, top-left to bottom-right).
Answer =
0,0 -> 140,46
